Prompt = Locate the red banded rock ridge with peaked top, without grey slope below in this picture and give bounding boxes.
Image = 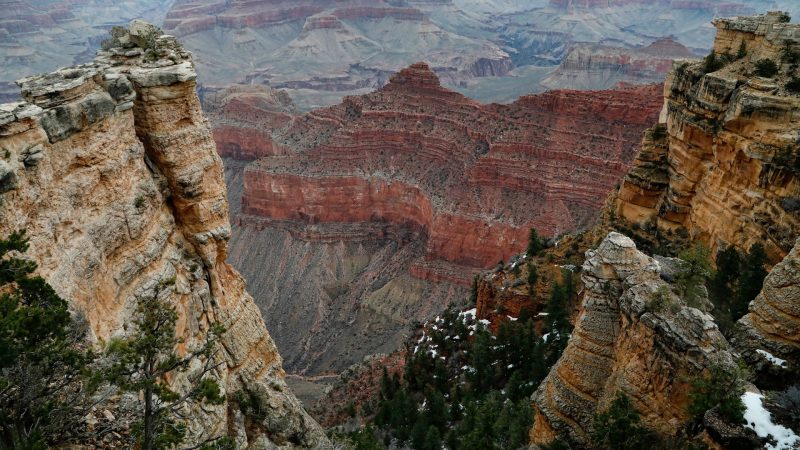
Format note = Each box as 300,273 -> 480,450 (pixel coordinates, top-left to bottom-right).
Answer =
242,63 -> 661,274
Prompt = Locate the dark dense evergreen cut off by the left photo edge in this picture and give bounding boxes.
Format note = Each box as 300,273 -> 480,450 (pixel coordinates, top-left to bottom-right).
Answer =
0,232 -> 93,450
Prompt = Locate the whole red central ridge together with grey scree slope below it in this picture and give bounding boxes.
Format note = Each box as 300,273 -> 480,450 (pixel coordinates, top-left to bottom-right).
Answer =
212,59 -> 661,376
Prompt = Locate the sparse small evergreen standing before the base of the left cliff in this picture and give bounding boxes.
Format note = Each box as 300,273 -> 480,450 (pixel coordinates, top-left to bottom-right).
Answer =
108,279 -> 224,450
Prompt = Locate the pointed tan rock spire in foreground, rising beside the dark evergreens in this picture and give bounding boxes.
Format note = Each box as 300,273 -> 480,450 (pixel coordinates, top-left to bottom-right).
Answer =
531,232 -> 734,448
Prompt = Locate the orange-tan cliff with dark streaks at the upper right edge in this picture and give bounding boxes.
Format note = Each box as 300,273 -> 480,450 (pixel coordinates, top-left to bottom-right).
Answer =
617,15 -> 800,263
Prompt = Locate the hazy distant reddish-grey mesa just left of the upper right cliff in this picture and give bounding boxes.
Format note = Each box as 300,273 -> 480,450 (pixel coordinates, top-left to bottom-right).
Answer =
542,38 -> 693,89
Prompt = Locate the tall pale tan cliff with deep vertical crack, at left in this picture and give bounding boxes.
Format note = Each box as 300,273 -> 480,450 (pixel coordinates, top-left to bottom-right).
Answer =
0,22 -> 327,448
